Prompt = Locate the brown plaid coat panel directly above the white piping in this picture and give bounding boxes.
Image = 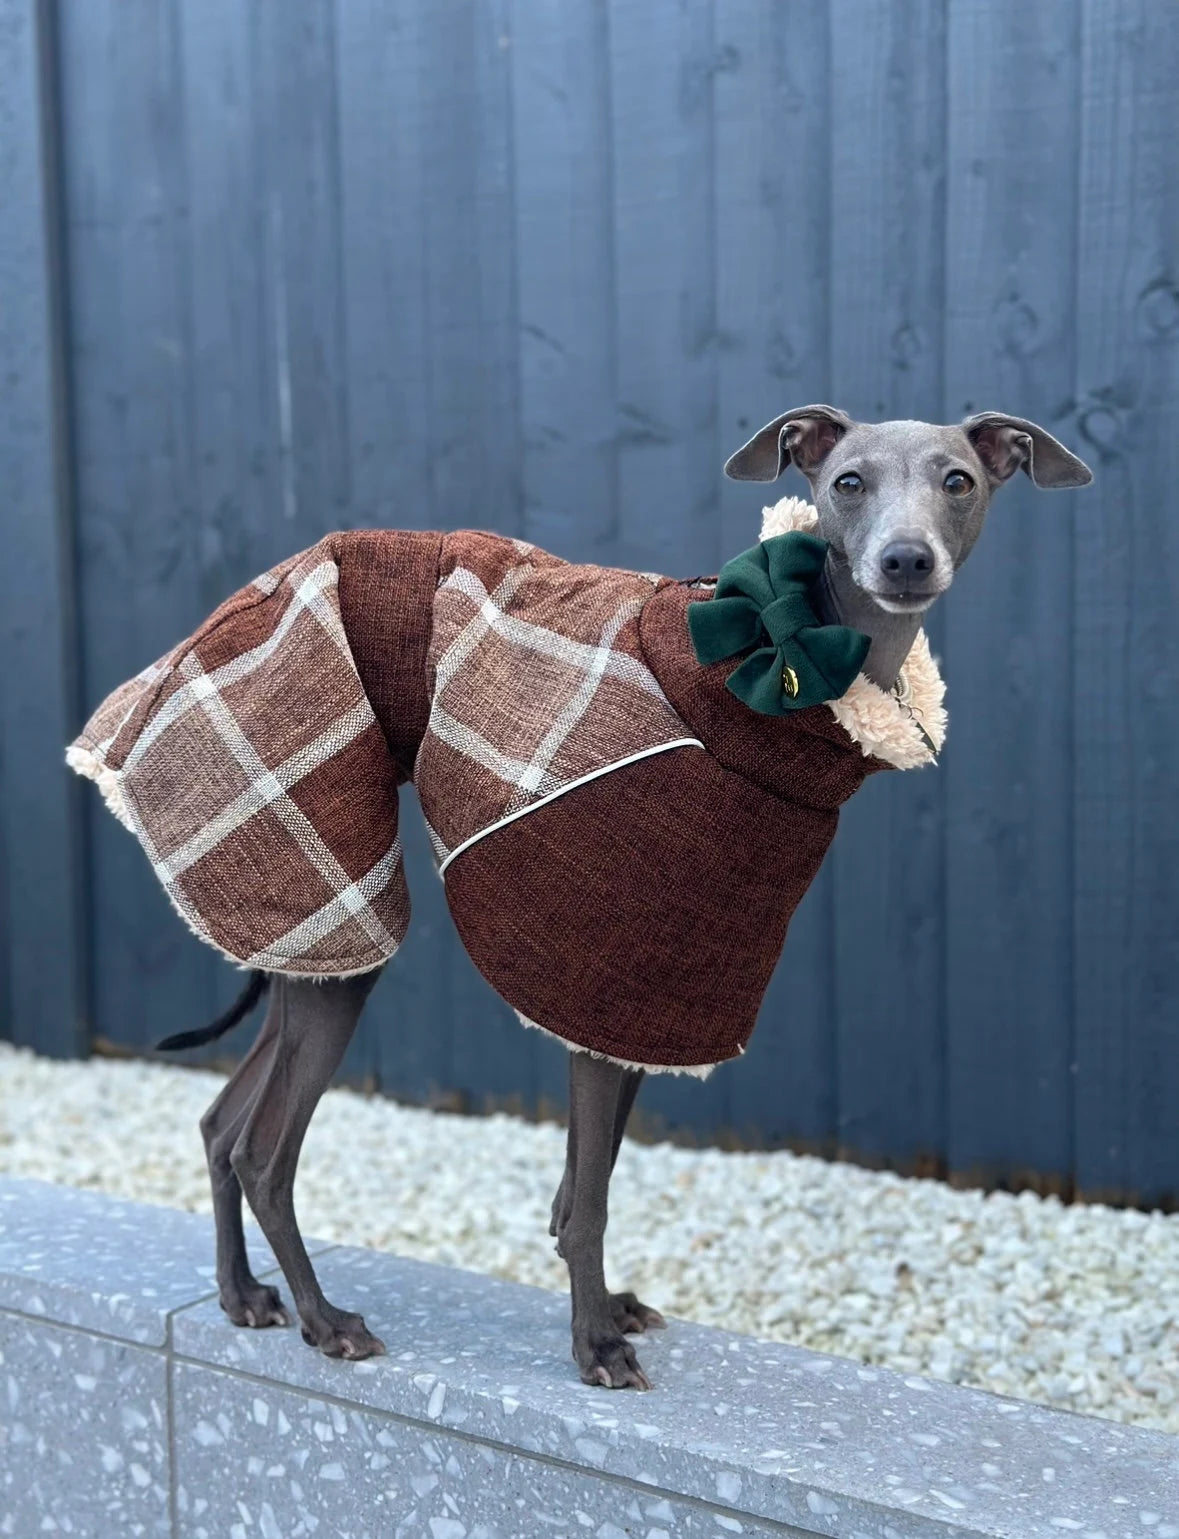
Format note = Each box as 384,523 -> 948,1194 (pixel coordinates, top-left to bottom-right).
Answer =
414,532 -> 691,862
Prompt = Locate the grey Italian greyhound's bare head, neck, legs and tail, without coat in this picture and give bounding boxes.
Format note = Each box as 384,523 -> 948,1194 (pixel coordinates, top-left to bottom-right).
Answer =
160,406 -> 1093,1390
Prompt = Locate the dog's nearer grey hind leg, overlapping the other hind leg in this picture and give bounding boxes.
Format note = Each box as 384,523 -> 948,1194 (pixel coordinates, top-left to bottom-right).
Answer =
229,973 -> 385,1357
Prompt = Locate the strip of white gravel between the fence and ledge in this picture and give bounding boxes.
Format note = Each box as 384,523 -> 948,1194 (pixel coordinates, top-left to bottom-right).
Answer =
0,1043 -> 1179,1433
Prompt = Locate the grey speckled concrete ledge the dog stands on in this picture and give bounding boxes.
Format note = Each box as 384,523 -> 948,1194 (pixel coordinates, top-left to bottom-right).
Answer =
0,1180 -> 1179,1539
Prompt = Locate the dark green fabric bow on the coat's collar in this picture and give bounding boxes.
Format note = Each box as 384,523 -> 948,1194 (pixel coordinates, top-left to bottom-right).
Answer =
688,531 -> 871,716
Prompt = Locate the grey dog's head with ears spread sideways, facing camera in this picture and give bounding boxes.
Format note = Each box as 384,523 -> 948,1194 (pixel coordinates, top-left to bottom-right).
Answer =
725,406 -> 1093,614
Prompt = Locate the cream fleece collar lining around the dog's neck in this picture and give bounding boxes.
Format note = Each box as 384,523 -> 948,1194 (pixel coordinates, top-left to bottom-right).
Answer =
760,497 -> 947,770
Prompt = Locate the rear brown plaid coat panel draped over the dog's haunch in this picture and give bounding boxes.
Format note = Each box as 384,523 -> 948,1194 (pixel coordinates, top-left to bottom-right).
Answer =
71,537 -> 409,974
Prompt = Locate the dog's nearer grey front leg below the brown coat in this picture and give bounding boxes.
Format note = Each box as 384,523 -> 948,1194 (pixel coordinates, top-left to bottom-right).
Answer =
554,1053 -> 662,1390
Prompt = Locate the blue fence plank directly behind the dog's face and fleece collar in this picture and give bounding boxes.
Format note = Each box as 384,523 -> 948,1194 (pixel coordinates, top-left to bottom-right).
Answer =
830,0 -> 956,1168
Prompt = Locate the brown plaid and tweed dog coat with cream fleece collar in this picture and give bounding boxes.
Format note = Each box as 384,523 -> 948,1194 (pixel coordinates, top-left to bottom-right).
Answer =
68,500 -> 942,1073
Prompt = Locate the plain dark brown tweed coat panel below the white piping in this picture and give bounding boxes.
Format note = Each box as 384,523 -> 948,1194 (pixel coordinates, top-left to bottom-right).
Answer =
446,748 -> 836,1068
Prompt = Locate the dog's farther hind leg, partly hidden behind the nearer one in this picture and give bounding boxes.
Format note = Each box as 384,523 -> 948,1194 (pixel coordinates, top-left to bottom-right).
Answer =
200,988 -> 291,1327
